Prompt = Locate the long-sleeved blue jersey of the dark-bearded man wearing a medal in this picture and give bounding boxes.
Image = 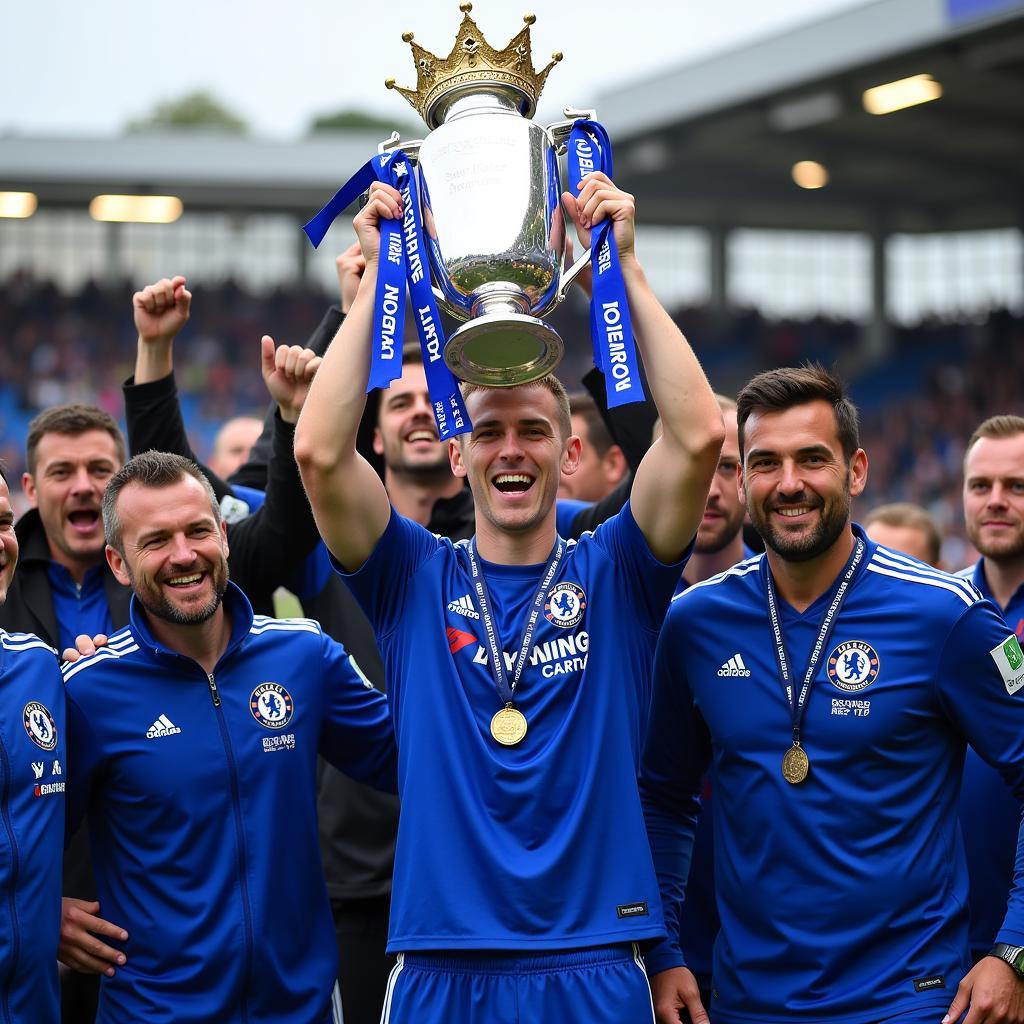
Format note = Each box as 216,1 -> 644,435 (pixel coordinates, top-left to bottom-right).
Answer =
641,527 -> 1024,1024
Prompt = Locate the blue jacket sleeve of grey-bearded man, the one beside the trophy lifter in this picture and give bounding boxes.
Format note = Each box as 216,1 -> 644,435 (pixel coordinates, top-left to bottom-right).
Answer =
319,633 -> 398,793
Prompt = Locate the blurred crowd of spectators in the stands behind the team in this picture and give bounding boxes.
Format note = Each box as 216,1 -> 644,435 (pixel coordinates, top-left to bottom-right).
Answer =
0,274 -> 1024,568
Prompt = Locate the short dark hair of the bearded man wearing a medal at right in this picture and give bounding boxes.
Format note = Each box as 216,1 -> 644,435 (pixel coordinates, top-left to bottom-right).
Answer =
736,362 -> 860,462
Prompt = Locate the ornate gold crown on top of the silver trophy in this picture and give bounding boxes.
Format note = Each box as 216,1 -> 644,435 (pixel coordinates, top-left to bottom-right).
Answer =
384,0 -> 562,128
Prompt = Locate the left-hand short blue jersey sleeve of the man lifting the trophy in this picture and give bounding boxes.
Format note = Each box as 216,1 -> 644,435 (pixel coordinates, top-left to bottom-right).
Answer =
331,507 -> 440,641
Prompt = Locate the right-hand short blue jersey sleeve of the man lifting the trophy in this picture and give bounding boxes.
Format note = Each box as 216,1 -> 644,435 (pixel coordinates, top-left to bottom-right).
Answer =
594,502 -> 693,631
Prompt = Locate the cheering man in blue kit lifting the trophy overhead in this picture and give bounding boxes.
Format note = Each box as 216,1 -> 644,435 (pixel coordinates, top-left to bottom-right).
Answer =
295,169 -> 723,1024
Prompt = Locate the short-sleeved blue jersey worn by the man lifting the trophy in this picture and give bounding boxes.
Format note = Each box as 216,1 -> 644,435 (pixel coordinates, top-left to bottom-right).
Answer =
344,505 -> 681,951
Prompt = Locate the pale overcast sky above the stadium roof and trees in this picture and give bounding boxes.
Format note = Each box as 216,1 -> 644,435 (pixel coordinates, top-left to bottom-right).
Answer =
0,0 -> 865,144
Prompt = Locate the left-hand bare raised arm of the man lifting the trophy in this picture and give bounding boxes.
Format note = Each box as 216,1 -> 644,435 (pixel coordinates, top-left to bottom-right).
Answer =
295,182 -> 401,571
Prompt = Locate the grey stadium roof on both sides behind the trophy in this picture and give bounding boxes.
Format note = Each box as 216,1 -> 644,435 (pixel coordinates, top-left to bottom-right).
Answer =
0,0 -> 1024,232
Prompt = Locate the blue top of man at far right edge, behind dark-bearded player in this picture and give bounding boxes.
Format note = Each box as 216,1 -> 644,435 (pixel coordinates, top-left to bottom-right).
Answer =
956,559 -> 1024,959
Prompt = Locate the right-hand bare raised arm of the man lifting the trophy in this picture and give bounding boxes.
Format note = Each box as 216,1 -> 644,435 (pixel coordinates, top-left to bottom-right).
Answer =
563,173 -> 725,562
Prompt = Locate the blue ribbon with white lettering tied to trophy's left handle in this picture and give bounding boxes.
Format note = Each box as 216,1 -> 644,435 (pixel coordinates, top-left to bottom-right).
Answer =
303,150 -> 472,441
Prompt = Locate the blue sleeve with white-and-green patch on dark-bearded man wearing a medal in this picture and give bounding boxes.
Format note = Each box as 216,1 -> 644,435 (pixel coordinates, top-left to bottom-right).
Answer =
937,601 -> 1024,946
